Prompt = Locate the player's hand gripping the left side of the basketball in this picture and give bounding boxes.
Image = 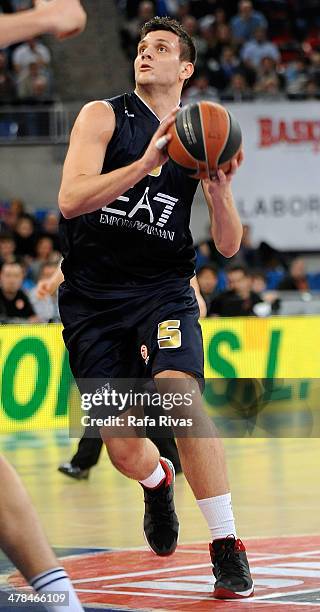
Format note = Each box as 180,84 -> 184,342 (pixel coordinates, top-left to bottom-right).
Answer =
142,107 -> 179,173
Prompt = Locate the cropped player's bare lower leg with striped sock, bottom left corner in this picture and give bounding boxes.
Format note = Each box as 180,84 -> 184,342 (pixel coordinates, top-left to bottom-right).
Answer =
0,456 -> 83,612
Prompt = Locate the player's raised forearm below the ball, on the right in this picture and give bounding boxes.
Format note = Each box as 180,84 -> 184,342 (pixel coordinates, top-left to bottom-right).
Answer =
202,158 -> 242,257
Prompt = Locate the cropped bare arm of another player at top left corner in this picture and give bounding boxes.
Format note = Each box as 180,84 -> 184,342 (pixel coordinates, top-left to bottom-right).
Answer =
0,0 -> 87,47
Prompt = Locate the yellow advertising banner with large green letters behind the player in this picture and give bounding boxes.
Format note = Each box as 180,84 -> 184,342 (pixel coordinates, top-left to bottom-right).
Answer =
0,316 -> 320,433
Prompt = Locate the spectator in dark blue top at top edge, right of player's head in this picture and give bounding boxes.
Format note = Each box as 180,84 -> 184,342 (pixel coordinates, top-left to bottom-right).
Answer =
230,0 -> 268,45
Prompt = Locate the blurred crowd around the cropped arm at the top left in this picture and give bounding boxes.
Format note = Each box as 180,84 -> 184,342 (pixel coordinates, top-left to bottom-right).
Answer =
0,0 -> 53,105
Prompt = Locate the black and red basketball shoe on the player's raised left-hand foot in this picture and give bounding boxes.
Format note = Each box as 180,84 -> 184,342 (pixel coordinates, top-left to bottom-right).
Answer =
143,457 -> 179,557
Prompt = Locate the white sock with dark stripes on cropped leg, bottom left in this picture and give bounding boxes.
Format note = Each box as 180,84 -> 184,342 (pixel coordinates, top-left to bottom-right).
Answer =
29,567 -> 83,612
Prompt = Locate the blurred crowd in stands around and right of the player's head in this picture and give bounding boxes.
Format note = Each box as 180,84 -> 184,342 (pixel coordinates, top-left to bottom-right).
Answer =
117,0 -> 320,103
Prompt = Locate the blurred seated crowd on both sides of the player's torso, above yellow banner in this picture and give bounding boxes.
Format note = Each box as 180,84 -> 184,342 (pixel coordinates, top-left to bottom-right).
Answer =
0,200 -> 320,323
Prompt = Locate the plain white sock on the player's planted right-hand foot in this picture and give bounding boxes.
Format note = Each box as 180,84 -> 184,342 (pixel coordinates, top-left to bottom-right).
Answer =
197,493 -> 237,540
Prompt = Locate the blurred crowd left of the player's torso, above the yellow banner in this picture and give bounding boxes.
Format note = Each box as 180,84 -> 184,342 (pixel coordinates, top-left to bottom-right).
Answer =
0,200 -> 61,323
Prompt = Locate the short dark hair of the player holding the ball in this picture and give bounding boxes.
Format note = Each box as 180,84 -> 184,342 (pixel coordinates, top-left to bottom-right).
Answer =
140,17 -> 197,65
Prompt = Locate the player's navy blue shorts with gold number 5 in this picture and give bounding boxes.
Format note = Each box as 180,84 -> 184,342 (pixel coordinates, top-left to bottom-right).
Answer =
59,280 -> 204,381
